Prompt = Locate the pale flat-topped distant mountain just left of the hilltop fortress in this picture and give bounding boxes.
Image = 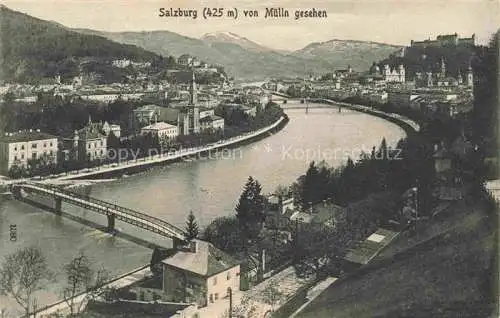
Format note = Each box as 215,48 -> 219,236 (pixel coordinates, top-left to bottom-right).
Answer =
292,40 -> 403,71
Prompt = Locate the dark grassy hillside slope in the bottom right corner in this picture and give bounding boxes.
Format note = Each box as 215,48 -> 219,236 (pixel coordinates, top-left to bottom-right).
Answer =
297,199 -> 498,318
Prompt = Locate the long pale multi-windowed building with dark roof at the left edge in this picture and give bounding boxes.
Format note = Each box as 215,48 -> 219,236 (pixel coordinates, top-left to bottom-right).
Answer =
0,130 -> 58,175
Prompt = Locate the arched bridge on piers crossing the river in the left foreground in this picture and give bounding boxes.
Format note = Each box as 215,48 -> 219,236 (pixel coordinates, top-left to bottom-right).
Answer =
12,183 -> 186,241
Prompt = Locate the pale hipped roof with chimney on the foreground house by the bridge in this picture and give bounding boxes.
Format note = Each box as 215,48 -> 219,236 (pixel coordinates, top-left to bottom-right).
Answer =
162,239 -> 240,277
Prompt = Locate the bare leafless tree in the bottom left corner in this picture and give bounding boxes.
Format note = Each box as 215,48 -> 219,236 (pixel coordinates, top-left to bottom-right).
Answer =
0,247 -> 52,317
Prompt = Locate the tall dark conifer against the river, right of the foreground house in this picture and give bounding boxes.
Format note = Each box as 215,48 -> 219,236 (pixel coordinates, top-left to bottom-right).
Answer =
236,176 -> 265,246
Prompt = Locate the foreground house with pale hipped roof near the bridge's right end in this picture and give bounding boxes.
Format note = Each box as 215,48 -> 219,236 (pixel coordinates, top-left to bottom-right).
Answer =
162,239 -> 240,306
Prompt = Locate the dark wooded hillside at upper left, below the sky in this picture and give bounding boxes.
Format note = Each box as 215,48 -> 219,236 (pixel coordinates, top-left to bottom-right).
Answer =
0,6 -> 158,82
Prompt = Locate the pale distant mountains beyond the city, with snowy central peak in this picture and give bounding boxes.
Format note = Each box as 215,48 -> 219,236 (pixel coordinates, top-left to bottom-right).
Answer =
77,30 -> 399,80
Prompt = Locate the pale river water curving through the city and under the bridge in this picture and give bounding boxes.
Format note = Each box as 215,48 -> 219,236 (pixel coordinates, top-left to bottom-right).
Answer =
0,102 -> 405,312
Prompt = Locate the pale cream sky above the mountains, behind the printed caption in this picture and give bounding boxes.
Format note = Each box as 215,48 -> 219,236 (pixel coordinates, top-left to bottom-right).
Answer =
2,0 -> 500,50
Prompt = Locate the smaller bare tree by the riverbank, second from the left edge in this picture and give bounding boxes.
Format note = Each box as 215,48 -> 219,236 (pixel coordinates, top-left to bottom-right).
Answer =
63,253 -> 108,317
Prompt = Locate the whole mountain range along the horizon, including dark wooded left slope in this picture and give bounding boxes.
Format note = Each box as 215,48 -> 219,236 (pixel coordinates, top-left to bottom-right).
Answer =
1,6 -> 401,80
